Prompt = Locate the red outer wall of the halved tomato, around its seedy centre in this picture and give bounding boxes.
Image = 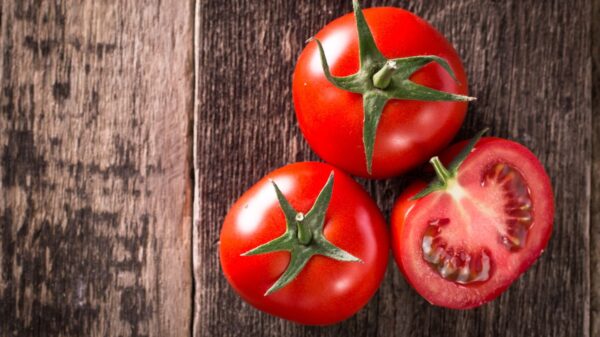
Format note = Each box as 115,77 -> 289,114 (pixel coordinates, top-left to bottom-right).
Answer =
391,137 -> 554,309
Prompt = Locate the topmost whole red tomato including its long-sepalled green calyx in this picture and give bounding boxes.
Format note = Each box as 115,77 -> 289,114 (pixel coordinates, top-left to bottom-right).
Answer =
293,1 -> 472,178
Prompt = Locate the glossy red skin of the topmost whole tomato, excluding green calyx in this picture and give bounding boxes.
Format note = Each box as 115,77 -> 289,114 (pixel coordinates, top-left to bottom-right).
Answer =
292,7 -> 467,178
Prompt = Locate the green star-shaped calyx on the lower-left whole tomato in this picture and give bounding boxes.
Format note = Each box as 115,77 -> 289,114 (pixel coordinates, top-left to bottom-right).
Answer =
242,171 -> 362,296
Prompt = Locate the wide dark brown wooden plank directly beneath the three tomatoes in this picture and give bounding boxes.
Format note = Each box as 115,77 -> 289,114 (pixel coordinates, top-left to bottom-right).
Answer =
193,0 -> 597,336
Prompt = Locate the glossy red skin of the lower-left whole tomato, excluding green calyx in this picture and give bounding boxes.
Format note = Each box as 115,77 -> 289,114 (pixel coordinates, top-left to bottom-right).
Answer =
219,162 -> 389,325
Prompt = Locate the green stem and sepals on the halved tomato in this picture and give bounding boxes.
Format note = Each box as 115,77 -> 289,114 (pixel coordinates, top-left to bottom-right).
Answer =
411,128 -> 489,200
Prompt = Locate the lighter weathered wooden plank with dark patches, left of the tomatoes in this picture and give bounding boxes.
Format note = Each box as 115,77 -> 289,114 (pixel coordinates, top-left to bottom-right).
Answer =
0,0 -> 194,336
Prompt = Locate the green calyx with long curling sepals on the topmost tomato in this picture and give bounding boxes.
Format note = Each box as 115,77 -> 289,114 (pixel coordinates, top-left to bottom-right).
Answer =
309,0 -> 475,174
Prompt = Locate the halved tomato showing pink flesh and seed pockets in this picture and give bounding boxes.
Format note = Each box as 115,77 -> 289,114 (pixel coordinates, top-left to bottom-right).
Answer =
391,137 -> 554,309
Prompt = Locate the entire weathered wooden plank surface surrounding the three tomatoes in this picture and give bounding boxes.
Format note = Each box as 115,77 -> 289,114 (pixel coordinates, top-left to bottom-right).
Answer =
0,0 -> 600,336
